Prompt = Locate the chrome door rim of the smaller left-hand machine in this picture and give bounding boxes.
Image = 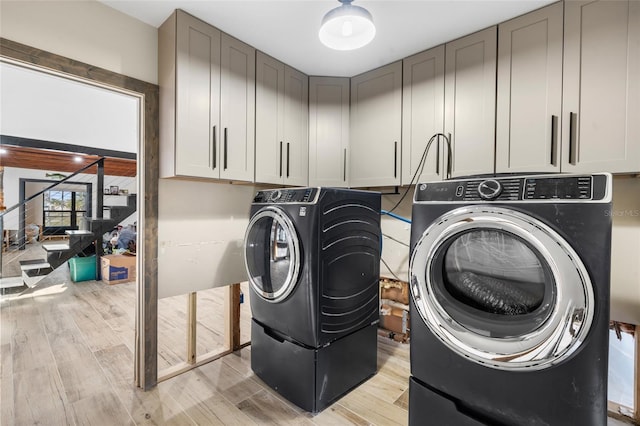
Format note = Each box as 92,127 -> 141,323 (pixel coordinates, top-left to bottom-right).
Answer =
244,206 -> 302,303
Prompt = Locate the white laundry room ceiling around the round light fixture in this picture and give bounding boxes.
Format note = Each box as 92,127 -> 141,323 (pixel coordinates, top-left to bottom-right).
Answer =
100,0 -> 556,77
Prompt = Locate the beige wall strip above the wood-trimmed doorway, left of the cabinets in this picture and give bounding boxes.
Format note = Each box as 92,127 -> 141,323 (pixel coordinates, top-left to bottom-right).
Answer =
0,0 -> 158,84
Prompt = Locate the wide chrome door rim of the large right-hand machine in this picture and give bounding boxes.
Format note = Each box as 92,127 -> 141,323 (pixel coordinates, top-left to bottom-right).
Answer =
409,205 -> 594,370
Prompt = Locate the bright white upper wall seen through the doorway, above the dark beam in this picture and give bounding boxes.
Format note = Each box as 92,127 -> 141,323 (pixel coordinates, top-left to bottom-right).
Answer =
0,63 -> 140,153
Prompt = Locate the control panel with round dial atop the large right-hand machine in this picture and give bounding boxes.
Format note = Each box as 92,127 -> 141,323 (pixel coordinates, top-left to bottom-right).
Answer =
414,174 -> 610,202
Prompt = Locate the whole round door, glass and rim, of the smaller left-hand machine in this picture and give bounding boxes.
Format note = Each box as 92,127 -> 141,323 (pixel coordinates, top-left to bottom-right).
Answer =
244,206 -> 302,302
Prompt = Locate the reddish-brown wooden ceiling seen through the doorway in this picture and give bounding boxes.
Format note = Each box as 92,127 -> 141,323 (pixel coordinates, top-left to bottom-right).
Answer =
0,144 -> 136,177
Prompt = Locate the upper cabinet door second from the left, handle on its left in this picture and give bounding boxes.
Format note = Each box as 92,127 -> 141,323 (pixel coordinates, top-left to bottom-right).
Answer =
220,33 -> 256,181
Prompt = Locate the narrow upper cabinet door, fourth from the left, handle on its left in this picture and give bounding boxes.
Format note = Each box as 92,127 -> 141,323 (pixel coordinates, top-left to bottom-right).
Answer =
283,66 -> 309,186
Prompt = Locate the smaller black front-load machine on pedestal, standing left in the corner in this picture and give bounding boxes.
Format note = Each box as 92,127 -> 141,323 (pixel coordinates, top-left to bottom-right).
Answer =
245,188 -> 381,412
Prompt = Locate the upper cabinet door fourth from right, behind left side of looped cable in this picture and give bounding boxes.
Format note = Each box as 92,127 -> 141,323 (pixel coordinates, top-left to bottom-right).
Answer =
401,45 -> 444,185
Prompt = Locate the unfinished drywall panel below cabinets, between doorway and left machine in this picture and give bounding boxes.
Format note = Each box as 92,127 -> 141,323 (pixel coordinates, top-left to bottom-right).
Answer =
158,179 -> 255,298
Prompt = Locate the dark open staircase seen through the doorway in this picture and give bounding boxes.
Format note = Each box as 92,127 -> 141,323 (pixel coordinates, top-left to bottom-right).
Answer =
20,194 -> 137,287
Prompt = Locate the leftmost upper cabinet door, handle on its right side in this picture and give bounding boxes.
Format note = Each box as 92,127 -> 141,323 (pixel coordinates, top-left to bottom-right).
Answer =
175,13 -> 220,178
